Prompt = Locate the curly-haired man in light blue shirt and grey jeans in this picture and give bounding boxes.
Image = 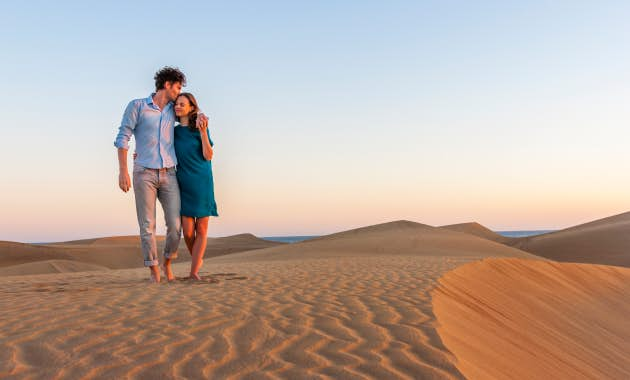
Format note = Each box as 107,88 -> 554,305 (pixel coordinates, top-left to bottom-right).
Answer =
114,67 -> 208,282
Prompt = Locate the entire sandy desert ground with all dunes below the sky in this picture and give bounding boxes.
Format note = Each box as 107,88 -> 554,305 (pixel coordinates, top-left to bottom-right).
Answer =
0,213 -> 630,379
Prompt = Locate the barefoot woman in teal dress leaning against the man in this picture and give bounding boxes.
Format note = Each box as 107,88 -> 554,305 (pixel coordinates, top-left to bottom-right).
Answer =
165,92 -> 219,280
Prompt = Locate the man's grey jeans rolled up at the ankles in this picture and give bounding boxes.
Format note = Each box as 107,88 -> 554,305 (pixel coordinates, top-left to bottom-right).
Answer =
133,164 -> 182,267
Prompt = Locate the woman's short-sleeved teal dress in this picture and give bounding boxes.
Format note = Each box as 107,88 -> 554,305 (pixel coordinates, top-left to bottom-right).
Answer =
175,125 -> 219,218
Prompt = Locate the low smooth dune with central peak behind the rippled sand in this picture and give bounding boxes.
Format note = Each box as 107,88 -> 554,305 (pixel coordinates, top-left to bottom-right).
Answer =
211,221 -> 537,260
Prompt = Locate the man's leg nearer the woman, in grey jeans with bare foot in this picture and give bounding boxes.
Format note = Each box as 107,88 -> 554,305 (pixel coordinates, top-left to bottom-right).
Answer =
157,169 -> 182,280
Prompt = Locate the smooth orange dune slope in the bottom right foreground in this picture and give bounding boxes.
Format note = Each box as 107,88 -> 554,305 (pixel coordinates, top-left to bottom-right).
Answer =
433,259 -> 630,379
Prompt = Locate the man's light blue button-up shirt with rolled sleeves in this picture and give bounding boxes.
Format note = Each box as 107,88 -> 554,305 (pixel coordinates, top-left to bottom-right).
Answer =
114,94 -> 177,169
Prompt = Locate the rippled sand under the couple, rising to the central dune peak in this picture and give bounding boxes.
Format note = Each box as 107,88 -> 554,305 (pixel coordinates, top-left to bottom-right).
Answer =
0,222 -> 531,379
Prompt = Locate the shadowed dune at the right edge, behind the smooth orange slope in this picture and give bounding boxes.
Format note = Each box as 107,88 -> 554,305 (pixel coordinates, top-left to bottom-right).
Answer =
510,212 -> 630,267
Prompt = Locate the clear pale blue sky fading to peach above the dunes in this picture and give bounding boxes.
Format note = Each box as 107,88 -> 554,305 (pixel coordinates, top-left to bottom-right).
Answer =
0,0 -> 630,242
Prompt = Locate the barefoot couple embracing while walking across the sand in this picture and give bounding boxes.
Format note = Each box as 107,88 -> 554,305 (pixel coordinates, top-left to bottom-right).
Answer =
114,67 -> 218,282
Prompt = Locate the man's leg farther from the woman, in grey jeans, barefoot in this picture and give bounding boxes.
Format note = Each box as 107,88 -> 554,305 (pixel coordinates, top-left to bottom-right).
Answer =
133,167 -> 160,281
